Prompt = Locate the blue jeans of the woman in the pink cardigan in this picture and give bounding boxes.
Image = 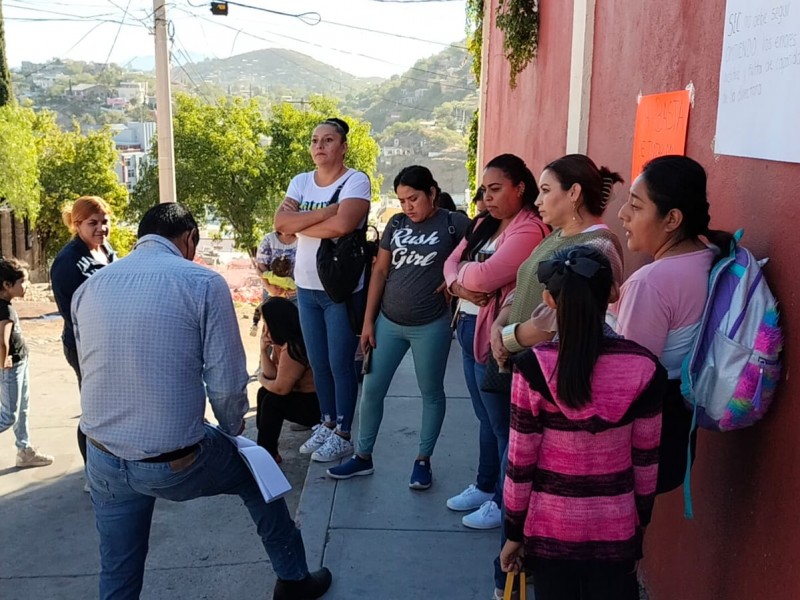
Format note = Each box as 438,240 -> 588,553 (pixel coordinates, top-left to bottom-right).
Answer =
456,313 -> 511,507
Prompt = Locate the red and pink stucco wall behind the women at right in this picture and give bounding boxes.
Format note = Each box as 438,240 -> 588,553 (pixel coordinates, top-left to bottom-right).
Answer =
484,0 -> 800,600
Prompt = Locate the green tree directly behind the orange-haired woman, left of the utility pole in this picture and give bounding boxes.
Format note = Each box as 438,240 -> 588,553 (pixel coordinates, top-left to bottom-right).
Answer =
34,112 -> 128,260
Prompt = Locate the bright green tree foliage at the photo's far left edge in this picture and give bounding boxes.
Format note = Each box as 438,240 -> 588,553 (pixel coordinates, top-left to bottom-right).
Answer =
0,103 -> 39,222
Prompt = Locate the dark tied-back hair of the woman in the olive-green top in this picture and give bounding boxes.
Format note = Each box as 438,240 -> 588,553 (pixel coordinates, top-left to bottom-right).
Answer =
544,154 -> 624,217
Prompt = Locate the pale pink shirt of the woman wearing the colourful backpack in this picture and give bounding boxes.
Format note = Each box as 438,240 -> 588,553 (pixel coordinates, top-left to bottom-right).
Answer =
608,248 -> 715,379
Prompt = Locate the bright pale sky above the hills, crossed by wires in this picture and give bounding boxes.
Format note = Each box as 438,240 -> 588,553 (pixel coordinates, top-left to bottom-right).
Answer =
3,0 -> 465,77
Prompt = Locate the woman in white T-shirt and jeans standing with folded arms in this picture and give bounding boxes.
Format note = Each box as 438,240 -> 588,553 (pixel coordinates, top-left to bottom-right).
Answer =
275,119 -> 372,462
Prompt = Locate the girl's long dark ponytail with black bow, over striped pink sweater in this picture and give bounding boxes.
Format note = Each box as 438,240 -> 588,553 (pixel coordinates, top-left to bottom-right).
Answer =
538,246 -> 614,408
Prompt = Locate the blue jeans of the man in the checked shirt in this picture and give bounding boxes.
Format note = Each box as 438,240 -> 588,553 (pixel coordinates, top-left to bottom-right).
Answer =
86,426 -> 308,600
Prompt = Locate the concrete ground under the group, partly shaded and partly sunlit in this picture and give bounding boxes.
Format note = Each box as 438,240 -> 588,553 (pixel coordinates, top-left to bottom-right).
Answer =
0,322 -> 499,600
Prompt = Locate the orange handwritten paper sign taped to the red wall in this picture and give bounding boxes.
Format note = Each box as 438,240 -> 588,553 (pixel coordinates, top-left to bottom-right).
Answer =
631,90 -> 689,183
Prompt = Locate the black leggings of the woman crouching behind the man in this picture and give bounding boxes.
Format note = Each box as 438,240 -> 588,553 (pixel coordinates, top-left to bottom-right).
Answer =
256,387 -> 321,456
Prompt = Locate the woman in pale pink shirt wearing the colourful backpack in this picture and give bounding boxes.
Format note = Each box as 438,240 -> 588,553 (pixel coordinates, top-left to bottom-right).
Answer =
609,156 -> 731,493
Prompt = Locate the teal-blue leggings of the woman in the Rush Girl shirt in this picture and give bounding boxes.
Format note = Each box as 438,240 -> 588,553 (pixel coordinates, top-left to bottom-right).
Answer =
358,313 -> 452,456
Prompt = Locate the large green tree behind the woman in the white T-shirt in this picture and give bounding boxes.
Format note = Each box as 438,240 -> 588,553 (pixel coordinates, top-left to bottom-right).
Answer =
128,94 -> 379,253
